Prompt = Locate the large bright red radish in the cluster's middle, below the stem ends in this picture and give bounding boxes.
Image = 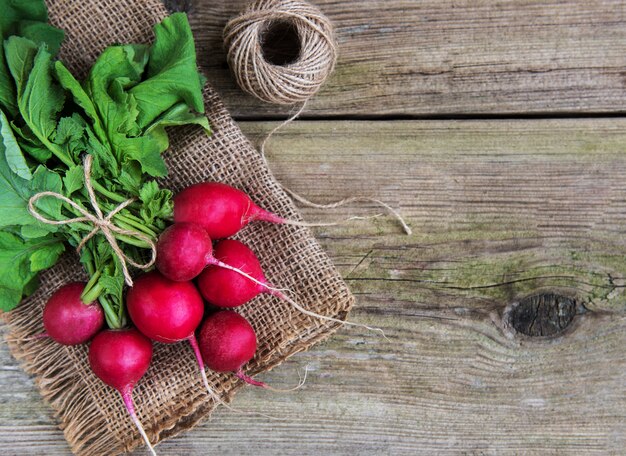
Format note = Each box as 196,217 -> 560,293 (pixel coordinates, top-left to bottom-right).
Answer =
126,271 -> 221,402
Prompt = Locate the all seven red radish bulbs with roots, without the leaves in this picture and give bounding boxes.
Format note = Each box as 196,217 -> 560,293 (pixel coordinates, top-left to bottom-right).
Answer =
37,182 -> 375,454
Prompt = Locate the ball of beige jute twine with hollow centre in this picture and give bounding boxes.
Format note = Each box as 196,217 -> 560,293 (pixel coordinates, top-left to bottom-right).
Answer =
224,0 -> 337,104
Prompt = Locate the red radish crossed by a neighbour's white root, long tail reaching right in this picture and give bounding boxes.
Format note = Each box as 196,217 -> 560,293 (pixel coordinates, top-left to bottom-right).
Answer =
197,239 -> 384,337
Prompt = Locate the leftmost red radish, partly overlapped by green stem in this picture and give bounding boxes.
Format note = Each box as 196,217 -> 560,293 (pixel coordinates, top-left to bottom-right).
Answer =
40,282 -> 104,345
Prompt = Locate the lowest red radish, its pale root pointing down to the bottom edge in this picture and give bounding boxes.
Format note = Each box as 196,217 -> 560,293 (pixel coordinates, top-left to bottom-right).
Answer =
89,329 -> 156,456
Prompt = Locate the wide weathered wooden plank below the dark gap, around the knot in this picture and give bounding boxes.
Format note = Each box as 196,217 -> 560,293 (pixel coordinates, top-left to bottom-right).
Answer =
0,119 -> 626,456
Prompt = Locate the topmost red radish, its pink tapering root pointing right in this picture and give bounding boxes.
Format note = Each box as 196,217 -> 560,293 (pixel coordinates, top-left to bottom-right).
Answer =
174,182 -> 290,240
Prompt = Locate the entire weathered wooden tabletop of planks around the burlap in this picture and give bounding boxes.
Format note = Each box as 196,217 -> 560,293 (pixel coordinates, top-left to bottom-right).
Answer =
0,0 -> 626,456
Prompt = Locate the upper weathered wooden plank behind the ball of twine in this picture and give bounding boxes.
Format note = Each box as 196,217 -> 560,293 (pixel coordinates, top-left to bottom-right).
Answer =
174,0 -> 626,118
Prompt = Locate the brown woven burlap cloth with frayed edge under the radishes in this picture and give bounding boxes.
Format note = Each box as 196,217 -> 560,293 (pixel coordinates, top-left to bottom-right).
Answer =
5,0 -> 354,455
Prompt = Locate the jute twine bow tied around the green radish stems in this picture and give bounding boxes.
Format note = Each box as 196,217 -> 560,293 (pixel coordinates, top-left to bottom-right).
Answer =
28,155 -> 156,287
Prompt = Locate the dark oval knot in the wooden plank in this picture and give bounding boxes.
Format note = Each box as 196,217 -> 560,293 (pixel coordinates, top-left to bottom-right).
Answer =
509,293 -> 576,337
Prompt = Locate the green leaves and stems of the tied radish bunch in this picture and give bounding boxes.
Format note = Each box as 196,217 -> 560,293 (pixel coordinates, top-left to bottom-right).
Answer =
0,0 -> 210,327
